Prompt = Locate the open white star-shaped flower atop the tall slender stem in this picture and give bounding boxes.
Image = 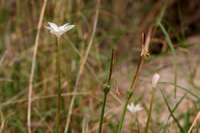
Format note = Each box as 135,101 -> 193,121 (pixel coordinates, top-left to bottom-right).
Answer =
45,22 -> 74,37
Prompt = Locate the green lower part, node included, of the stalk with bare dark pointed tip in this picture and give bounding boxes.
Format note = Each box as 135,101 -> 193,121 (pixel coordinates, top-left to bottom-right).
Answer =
98,85 -> 110,133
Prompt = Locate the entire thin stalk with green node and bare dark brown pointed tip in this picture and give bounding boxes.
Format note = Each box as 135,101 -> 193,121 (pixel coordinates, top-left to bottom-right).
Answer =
98,49 -> 114,133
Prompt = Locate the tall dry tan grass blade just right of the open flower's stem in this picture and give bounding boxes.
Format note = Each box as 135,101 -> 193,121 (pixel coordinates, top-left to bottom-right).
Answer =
64,0 -> 100,133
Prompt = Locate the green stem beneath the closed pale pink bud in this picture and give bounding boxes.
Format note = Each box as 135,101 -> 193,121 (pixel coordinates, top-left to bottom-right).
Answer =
145,87 -> 156,133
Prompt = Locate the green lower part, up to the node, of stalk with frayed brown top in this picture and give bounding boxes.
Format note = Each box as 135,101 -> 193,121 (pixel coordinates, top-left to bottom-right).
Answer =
117,90 -> 133,133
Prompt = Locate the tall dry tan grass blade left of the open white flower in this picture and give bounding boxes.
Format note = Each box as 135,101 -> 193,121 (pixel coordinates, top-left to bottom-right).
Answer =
27,0 -> 47,133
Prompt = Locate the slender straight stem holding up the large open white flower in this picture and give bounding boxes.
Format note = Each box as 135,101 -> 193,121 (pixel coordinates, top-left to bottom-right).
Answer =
56,37 -> 62,133
